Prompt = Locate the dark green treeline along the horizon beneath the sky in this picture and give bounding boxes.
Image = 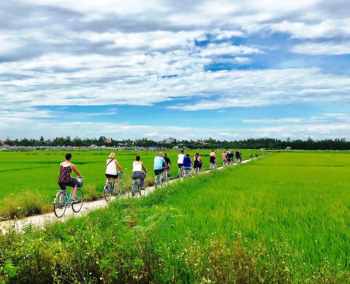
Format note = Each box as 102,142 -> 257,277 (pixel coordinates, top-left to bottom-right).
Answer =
0,136 -> 350,150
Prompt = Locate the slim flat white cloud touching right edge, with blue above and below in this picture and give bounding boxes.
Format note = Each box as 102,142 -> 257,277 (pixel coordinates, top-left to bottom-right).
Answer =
290,42 -> 350,55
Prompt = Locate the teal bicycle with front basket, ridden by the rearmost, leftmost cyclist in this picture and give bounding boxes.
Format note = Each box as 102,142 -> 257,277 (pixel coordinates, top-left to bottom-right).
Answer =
53,178 -> 84,218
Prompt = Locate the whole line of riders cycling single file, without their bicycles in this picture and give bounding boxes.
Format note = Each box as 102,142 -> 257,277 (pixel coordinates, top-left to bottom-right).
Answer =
58,149 -> 242,195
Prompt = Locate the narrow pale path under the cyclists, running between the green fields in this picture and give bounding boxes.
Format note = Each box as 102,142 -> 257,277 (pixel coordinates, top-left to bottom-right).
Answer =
0,158 -> 258,234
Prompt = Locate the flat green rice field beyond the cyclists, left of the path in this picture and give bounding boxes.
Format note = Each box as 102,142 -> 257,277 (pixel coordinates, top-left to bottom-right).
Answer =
0,150 -> 261,203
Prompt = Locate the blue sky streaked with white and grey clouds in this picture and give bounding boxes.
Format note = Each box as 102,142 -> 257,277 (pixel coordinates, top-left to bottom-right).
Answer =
0,0 -> 350,140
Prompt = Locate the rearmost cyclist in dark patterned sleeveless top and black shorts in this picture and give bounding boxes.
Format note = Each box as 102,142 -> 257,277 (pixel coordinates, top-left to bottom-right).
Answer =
58,153 -> 83,203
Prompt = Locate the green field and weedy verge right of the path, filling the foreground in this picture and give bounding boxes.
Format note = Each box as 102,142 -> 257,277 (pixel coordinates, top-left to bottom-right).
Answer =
0,153 -> 350,283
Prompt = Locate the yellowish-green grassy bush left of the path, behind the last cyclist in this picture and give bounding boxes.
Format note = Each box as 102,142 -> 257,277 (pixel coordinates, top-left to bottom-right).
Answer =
0,190 -> 52,219
